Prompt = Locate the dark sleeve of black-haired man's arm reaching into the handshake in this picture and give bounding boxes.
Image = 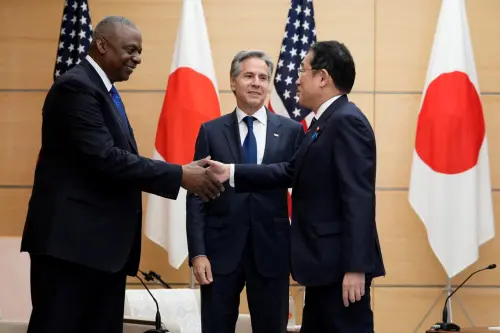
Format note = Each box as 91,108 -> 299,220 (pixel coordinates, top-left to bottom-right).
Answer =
234,126 -> 305,193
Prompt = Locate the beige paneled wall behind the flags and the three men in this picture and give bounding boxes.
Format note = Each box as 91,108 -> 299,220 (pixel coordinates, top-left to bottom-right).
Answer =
0,0 -> 500,332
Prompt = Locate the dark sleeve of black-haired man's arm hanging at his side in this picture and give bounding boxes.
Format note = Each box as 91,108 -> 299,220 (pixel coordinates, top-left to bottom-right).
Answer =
333,116 -> 376,273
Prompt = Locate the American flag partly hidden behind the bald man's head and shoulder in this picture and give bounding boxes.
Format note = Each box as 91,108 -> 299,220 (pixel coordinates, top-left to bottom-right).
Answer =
54,0 -> 92,80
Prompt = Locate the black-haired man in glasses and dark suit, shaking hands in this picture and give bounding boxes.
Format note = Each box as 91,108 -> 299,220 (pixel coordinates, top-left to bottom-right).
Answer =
209,41 -> 385,333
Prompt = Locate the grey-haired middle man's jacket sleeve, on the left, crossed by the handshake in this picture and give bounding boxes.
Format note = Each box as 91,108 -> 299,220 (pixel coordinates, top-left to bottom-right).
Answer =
186,125 -> 210,265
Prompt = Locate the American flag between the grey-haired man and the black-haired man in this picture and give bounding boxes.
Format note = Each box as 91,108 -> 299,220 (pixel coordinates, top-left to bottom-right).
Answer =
269,0 -> 316,129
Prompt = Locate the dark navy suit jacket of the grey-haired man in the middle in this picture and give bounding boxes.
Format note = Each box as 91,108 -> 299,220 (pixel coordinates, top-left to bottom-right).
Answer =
187,111 -> 304,277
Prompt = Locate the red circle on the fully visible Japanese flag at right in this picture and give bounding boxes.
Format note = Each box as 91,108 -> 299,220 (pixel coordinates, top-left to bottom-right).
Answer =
415,72 -> 485,174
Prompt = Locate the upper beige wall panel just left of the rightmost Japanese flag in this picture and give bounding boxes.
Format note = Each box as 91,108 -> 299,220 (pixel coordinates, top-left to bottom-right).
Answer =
375,0 -> 441,91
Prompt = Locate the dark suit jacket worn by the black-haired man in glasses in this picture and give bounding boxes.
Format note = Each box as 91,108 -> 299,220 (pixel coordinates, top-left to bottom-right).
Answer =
234,95 -> 385,286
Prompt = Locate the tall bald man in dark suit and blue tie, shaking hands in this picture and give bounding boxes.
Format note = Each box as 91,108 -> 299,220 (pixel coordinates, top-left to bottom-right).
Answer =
21,17 -> 222,333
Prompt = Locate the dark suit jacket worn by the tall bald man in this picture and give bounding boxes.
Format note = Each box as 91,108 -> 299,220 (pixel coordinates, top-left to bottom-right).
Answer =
21,61 -> 182,275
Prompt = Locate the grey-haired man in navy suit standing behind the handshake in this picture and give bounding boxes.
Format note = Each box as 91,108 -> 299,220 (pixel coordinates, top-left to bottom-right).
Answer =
187,51 -> 304,333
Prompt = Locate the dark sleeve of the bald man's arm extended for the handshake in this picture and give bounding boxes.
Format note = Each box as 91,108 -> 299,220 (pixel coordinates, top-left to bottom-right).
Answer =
56,80 -> 182,199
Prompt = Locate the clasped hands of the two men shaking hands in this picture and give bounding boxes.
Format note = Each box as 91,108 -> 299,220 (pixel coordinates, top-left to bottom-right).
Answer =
181,156 -> 230,202
